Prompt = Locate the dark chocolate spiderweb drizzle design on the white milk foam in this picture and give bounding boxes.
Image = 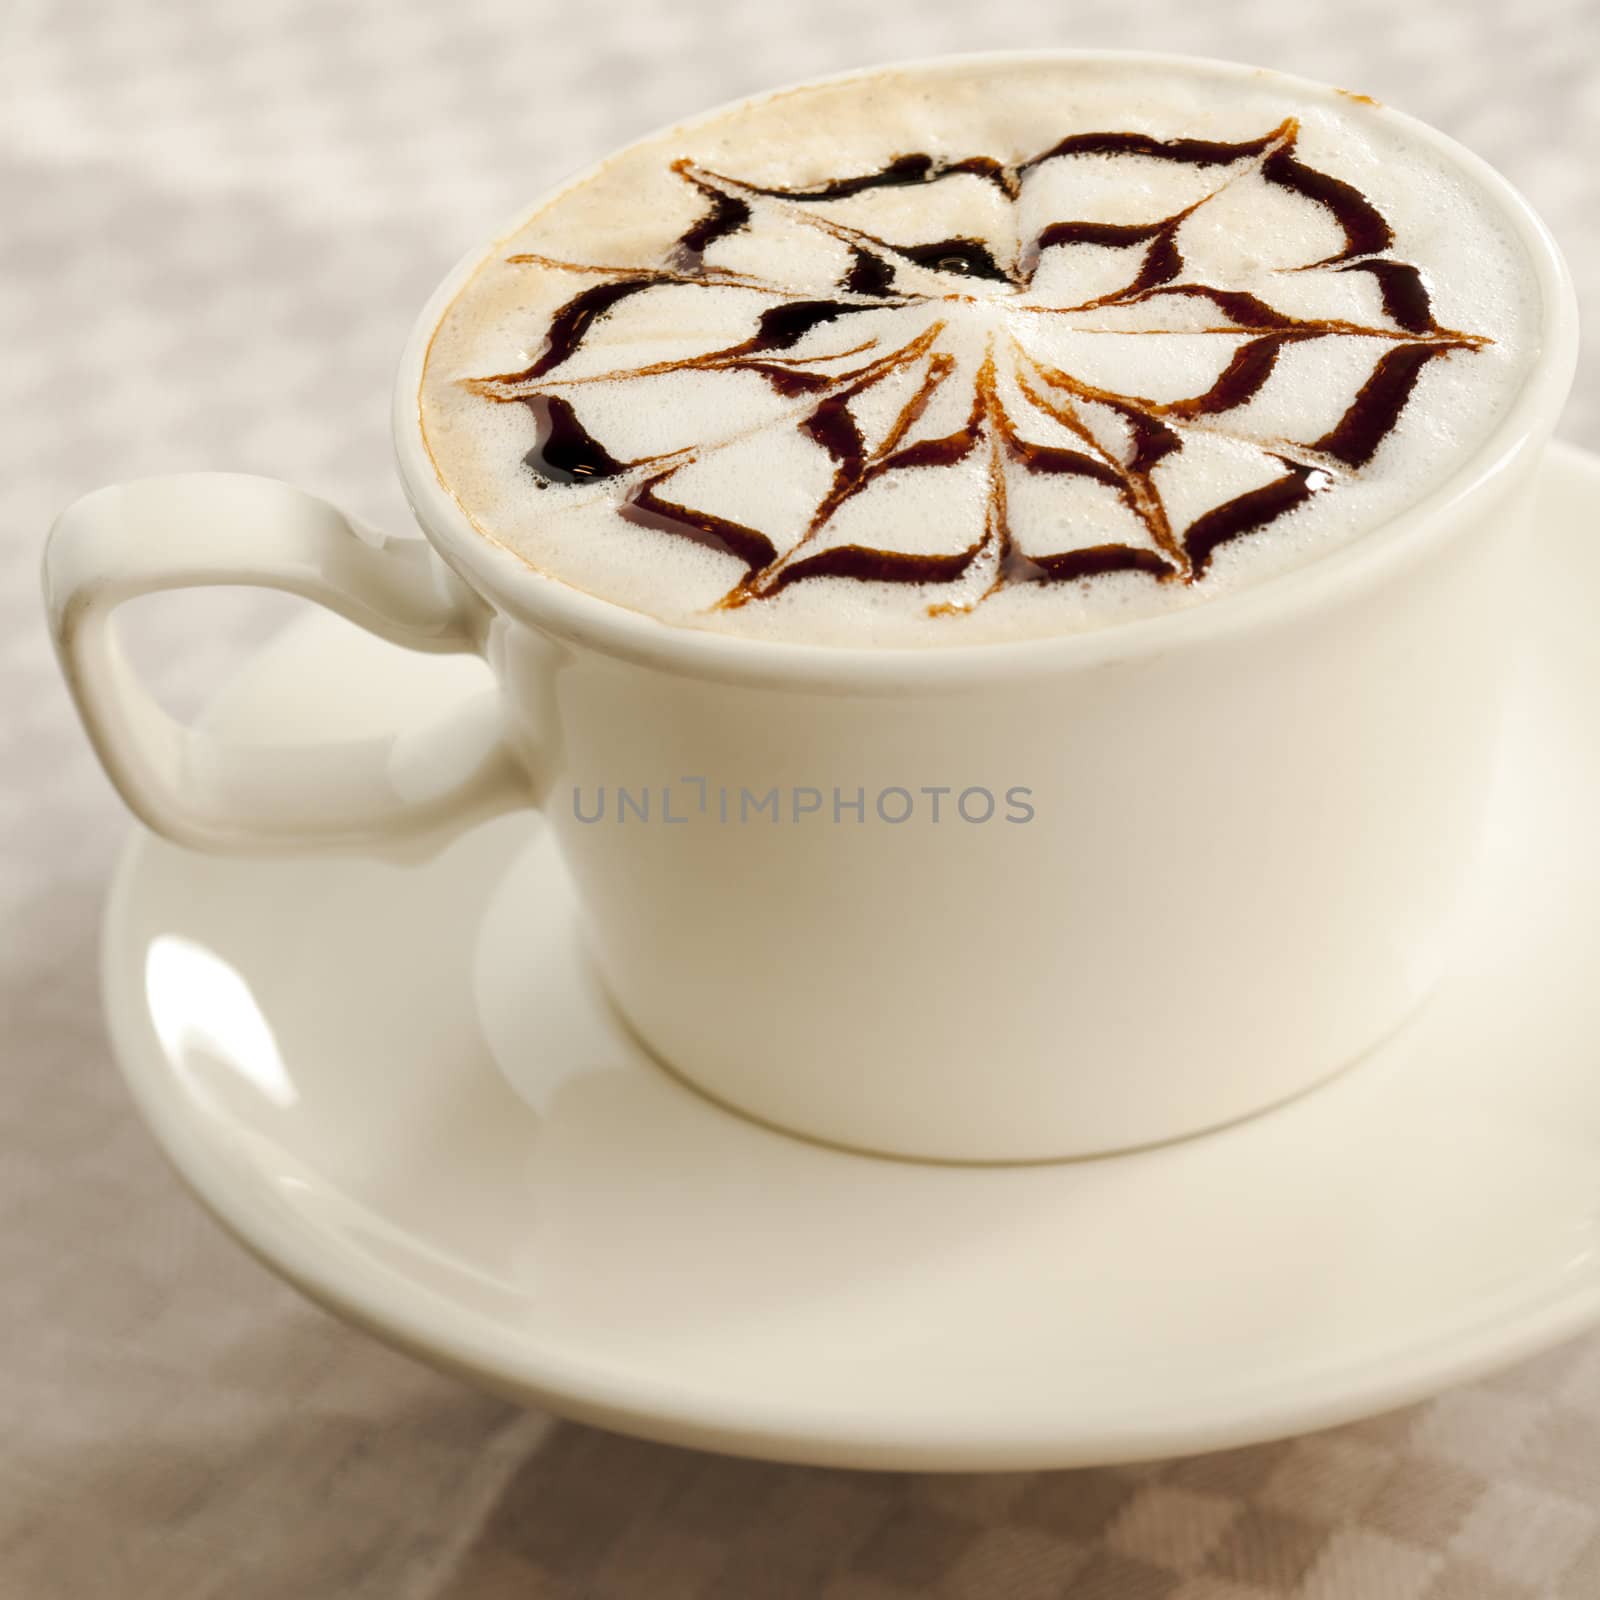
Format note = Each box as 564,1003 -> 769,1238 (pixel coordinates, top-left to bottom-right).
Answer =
469,120 -> 1490,614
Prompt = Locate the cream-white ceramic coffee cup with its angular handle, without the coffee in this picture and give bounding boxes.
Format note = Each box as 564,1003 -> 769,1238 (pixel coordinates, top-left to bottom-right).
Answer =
46,50 -> 1576,1160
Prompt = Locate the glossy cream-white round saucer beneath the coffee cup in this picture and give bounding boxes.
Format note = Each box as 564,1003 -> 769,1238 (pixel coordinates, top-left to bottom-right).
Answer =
104,450 -> 1600,1469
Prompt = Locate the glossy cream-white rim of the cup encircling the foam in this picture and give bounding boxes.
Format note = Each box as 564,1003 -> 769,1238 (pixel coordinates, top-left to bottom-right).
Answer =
392,50 -> 1578,693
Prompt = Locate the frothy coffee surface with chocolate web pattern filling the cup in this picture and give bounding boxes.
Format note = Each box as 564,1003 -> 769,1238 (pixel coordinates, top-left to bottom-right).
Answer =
421,58 -> 1533,645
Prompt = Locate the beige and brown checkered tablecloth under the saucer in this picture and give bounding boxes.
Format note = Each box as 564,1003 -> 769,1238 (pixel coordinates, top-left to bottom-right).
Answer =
0,0 -> 1600,1600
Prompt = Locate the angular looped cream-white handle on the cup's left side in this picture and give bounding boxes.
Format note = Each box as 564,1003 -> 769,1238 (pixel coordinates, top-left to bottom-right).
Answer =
45,472 -> 534,854
